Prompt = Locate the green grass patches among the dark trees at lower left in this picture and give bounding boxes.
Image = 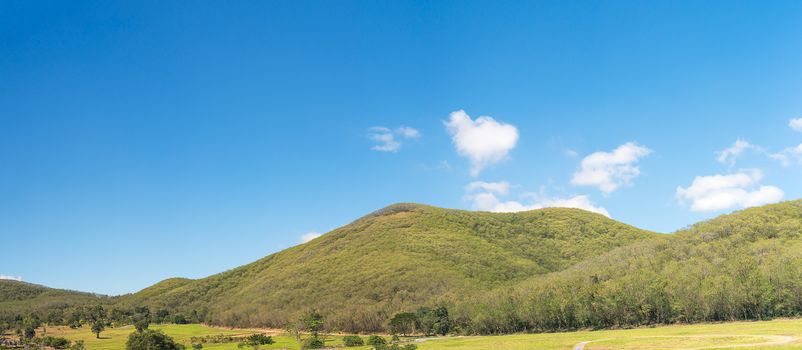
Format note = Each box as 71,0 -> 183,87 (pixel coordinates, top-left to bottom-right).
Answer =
47,324 -> 376,350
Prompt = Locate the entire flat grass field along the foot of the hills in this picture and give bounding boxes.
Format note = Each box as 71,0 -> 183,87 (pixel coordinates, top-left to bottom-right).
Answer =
42,319 -> 802,350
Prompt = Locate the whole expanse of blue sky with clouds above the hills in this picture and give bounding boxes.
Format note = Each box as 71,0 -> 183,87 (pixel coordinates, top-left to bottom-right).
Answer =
0,1 -> 802,294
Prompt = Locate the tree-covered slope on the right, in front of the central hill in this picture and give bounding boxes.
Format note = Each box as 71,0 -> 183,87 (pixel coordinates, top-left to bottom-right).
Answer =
458,200 -> 802,333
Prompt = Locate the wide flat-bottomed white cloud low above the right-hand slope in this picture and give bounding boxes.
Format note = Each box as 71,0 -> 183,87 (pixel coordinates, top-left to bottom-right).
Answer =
676,169 -> 784,212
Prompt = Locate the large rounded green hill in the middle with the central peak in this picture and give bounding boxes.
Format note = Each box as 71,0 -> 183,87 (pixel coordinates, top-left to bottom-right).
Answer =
121,204 -> 658,331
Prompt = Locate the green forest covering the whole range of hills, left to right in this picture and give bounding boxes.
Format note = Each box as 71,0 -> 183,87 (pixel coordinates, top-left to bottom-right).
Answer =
0,201 -> 802,334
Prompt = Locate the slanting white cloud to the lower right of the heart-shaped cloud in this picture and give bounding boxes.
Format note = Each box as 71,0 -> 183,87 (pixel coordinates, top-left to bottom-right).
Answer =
571,142 -> 652,194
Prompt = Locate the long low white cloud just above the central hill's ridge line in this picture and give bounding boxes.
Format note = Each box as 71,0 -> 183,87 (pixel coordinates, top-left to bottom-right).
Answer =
465,185 -> 610,217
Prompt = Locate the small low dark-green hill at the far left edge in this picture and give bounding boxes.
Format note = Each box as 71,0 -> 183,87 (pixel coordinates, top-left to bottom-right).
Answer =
0,280 -> 109,319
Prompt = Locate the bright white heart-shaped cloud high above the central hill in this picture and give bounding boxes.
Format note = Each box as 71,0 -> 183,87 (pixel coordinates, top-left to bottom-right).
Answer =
445,110 -> 518,176
